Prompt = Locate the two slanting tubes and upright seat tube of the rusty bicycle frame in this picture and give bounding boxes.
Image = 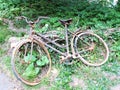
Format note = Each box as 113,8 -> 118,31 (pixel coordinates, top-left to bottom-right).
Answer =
30,25 -> 71,57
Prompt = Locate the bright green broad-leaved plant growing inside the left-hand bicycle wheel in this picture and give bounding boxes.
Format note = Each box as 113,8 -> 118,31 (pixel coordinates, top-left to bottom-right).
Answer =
23,54 -> 49,79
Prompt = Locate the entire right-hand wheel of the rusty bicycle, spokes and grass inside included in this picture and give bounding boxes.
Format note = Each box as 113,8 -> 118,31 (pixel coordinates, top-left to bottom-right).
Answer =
74,32 -> 109,66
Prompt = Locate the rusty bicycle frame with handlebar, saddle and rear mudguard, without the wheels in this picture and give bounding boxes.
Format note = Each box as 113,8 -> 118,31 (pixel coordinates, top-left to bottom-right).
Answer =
14,16 -> 107,65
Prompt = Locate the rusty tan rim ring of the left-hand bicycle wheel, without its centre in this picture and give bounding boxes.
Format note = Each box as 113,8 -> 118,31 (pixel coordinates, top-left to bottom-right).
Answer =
11,39 -> 51,86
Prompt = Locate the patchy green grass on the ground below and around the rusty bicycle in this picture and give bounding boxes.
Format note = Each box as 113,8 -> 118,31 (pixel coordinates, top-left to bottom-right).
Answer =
0,22 -> 120,90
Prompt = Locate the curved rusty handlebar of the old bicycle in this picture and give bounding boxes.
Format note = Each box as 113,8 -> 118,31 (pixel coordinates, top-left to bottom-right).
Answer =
16,16 -> 49,24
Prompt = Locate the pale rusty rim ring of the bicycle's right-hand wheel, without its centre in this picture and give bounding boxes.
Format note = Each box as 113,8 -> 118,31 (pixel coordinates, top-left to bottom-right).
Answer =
75,32 -> 109,66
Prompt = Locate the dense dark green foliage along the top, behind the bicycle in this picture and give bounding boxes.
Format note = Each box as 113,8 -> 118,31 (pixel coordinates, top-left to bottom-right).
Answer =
0,0 -> 120,29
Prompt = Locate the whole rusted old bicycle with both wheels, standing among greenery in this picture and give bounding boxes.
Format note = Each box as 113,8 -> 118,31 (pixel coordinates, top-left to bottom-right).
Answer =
11,16 -> 109,85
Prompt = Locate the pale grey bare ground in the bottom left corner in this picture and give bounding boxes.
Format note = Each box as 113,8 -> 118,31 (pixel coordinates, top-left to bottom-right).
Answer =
0,42 -> 24,90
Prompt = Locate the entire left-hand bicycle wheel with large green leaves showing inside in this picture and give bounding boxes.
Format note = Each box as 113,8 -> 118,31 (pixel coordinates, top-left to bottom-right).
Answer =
11,39 -> 51,85
